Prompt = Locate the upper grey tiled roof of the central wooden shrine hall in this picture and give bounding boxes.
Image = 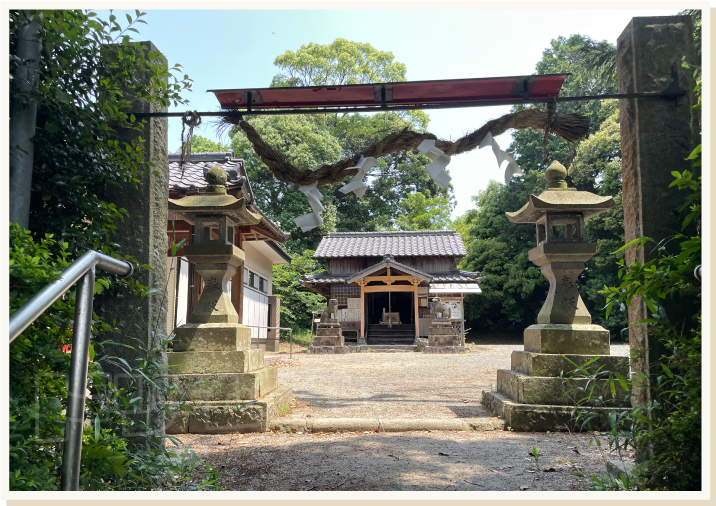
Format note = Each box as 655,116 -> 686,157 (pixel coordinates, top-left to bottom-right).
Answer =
313,230 -> 467,258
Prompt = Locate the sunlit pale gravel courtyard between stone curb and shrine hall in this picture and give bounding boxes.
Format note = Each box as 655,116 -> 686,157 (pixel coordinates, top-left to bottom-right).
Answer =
269,343 -> 629,419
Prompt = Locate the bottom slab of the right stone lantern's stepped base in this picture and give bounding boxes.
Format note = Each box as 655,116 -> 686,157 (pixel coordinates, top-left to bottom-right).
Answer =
482,390 -> 623,432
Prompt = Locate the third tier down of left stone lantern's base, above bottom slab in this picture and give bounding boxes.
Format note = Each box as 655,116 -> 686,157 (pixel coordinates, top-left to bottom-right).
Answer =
167,367 -> 278,401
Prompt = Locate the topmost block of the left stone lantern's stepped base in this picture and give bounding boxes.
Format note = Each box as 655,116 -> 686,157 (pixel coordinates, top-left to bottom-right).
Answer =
172,323 -> 251,351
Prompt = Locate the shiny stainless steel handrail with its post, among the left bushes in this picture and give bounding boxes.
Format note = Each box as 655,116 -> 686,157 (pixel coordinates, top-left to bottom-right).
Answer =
10,251 -> 133,490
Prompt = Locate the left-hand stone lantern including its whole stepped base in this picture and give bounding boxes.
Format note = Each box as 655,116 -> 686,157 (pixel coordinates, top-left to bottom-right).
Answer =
166,166 -> 292,434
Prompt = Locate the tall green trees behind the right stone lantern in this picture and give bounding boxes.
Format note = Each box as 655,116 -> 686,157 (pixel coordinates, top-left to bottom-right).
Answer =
455,35 -> 628,336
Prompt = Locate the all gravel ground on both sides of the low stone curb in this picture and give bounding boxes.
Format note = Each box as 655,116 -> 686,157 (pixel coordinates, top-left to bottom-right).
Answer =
173,342 -> 633,490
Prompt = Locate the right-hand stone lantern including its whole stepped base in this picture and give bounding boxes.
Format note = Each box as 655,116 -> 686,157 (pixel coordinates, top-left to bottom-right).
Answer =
482,162 -> 629,431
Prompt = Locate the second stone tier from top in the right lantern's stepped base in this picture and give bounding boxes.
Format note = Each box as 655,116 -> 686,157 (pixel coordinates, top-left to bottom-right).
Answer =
510,351 -> 629,378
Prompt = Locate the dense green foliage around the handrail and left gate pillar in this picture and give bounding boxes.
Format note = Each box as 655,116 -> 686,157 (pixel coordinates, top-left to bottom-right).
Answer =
9,10 -> 218,490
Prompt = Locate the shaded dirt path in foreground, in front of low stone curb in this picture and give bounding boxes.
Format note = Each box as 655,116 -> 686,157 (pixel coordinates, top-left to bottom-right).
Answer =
173,431 -> 628,491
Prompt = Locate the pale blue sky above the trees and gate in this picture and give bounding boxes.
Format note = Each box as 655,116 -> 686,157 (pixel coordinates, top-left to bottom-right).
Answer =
109,7 -> 678,218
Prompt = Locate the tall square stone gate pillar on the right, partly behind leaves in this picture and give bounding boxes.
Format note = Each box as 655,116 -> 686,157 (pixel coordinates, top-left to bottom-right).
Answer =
617,16 -> 700,405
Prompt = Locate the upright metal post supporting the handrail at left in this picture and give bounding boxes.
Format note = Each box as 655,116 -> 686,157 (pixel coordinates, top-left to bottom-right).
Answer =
60,266 -> 94,490
